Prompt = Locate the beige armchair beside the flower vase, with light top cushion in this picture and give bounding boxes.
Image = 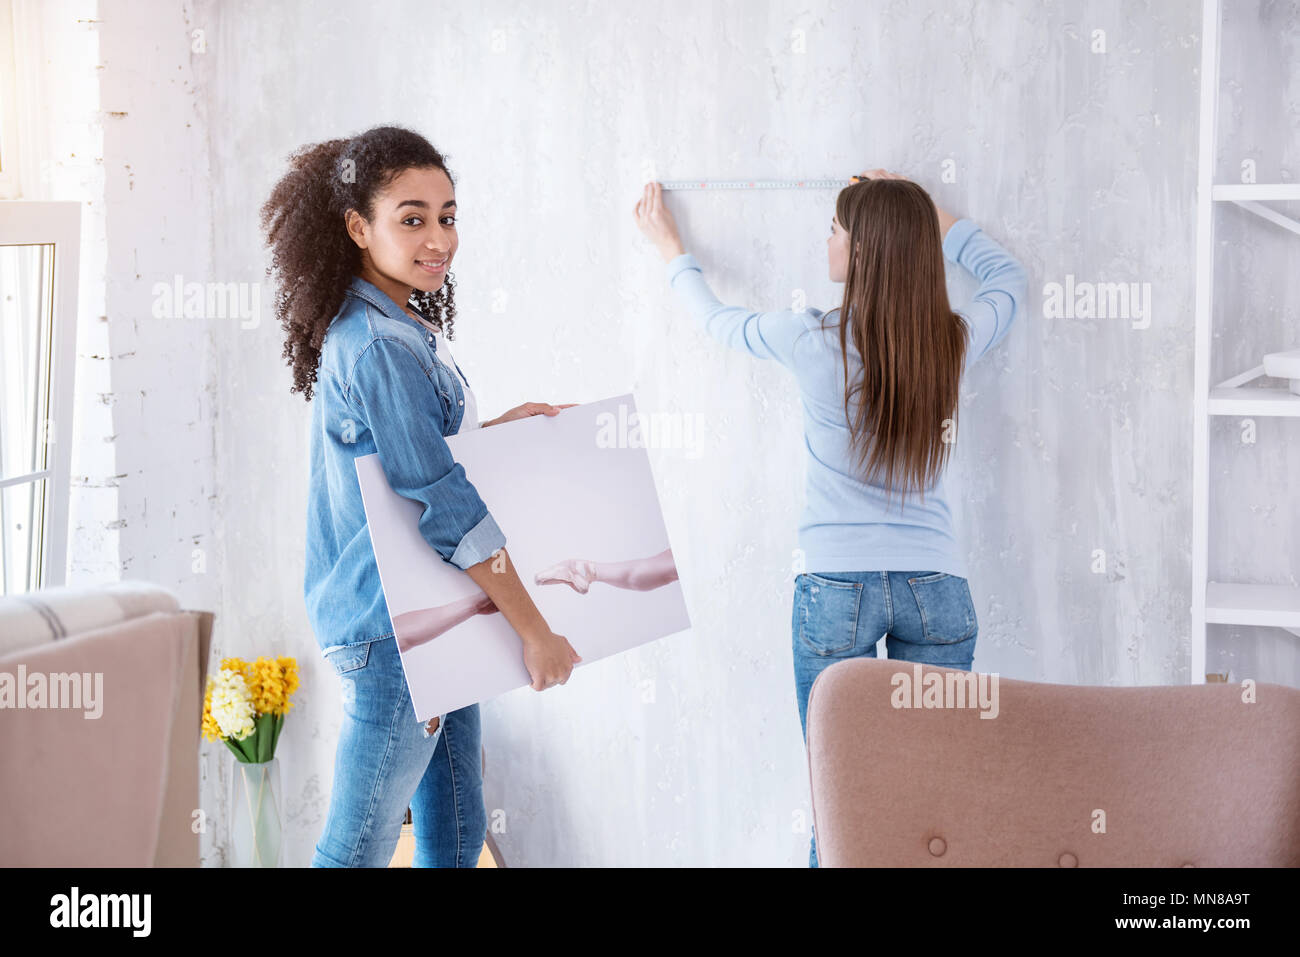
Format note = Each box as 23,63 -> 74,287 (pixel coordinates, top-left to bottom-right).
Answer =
0,583 -> 213,867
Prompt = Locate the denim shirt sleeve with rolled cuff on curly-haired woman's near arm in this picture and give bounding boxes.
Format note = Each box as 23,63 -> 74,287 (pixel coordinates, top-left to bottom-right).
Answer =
347,338 -> 506,570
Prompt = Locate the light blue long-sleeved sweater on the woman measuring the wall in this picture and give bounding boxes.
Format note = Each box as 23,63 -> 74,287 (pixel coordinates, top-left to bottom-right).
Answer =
667,220 -> 1028,577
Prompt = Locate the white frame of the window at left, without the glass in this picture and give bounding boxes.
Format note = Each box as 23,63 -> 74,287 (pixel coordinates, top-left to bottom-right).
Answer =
0,202 -> 81,589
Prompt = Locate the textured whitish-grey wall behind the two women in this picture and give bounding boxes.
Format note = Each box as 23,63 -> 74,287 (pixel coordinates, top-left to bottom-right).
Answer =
78,0 -> 1300,865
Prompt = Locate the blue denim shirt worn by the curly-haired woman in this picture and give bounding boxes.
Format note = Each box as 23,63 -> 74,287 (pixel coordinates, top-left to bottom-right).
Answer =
303,277 -> 506,654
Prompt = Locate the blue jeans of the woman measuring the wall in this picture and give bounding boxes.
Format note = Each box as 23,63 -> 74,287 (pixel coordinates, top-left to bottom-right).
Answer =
790,572 -> 979,867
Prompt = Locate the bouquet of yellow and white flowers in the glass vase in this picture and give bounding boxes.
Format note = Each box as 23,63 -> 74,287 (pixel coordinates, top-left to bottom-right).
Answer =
203,658 -> 298,763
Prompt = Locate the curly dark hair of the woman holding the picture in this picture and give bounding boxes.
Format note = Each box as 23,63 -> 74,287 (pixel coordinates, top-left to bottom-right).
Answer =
261,126 -> 456,402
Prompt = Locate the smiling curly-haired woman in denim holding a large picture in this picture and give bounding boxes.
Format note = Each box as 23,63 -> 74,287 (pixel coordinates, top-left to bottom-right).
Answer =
261,126 -> 581,867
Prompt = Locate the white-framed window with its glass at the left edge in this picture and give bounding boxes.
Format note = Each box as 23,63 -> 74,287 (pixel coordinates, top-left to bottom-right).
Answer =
0,202 -> 81,594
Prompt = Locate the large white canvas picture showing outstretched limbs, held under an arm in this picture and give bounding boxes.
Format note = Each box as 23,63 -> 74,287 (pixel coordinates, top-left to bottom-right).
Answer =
356,395 -> 690,722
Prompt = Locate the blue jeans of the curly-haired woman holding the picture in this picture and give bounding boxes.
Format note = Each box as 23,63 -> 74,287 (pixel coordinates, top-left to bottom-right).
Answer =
312,637 -> 488,867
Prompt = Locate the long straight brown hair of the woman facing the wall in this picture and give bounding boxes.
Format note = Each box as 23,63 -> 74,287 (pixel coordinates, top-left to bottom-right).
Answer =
835,179 -> 969,502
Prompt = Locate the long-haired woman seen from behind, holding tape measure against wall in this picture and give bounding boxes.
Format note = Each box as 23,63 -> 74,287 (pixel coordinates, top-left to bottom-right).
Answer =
634,169 -> 1027,867
